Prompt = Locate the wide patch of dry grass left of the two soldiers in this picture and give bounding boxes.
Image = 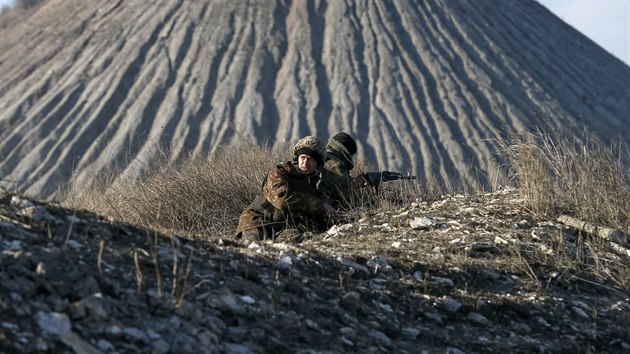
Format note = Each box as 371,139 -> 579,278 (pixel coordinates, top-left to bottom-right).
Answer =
64,145 -> 290,238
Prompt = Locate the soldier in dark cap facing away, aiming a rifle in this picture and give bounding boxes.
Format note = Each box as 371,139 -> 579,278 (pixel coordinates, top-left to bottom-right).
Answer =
319,132 -> 366,208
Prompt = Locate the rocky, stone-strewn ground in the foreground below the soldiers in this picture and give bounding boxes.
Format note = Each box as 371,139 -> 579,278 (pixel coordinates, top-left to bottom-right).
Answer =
0,190 -> 630,353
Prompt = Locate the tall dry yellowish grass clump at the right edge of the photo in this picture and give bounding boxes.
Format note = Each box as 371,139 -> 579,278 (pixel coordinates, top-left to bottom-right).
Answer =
499,129 -> 630,231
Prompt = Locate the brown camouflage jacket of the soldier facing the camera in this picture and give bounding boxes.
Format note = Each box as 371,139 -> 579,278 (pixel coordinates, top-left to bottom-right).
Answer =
236,162 -> 328,238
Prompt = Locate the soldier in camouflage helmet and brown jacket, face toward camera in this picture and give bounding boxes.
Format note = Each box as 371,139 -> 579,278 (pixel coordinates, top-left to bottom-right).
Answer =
236,136 -> 337,241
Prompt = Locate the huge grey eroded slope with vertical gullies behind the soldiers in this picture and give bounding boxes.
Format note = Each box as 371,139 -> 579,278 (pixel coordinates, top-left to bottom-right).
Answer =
0,0 -> 630,196
